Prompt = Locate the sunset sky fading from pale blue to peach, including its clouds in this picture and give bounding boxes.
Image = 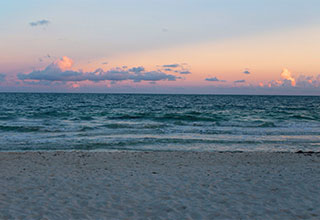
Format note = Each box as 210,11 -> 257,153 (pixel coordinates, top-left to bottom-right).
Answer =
0,0 -> 320,95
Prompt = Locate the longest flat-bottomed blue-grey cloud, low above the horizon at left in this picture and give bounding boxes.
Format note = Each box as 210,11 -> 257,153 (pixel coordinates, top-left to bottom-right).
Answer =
17,65 -> 181,82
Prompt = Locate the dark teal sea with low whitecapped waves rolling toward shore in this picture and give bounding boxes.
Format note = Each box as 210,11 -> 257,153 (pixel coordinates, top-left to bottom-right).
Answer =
0,93 -> 320,151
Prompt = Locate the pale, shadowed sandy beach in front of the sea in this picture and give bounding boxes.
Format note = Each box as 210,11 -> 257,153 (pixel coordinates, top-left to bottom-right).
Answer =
0,152 -> 320,219
